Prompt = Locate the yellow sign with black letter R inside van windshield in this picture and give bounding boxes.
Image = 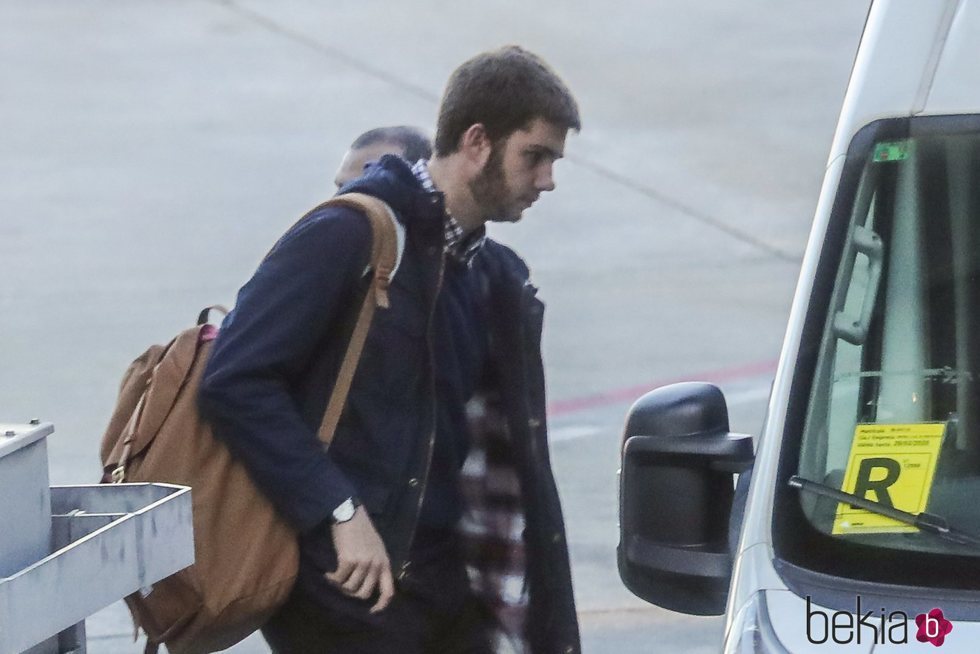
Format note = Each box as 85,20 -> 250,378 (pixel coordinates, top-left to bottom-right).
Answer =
833,422 -> 946,534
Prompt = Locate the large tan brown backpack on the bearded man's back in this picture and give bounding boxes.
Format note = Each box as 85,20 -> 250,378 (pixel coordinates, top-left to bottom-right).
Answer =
101,193 -> 403,654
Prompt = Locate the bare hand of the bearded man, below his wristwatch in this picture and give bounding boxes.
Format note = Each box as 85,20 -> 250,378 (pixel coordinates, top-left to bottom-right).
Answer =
324,506 -> 395,613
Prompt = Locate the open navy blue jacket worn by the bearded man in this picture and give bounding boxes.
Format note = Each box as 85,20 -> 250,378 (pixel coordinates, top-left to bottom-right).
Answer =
200,157 -> 579,652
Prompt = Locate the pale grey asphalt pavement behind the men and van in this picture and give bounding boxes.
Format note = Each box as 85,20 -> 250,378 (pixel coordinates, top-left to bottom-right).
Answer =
0,0 -> 868,654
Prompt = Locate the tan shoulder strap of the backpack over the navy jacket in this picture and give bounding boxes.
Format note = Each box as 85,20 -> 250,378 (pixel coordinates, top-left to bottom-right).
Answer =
317,193 -> 405,445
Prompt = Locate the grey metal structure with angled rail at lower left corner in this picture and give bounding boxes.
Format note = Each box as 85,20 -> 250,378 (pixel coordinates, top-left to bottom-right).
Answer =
0,423 -> 194,654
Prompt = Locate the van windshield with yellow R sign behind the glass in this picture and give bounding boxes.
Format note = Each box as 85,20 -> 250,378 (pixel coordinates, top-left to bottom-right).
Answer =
777,119 -> 980,585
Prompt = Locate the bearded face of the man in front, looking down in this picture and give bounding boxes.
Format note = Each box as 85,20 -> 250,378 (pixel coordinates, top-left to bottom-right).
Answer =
469,118 -> 568,222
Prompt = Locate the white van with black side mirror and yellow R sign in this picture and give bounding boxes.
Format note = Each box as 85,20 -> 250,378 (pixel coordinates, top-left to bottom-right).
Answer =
619,0 -> 980,654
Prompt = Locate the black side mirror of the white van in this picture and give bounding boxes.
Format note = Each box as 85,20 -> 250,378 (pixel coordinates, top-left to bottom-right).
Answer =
617,382 -> 753,615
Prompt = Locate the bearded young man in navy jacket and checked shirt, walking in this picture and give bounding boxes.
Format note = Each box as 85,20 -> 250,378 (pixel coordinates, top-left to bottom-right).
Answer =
201,46 -> 580,654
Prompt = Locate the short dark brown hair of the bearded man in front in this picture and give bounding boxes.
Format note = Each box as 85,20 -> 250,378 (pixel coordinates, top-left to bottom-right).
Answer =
435,45 -> 582,155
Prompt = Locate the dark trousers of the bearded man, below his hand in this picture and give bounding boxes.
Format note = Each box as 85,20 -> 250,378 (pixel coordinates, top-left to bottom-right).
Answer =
262,544 -> 493,654
